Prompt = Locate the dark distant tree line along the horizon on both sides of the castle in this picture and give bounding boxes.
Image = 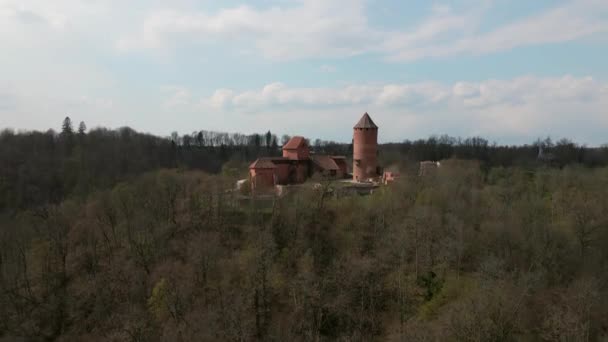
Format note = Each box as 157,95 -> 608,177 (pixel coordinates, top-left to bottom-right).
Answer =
0,117 -> 608,213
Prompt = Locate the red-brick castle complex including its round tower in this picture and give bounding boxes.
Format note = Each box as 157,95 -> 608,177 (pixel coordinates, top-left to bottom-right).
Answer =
249,113 -> 381,190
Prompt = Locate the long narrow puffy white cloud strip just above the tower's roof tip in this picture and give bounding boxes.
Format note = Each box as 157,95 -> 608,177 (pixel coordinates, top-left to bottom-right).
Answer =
203,76 -> 606,108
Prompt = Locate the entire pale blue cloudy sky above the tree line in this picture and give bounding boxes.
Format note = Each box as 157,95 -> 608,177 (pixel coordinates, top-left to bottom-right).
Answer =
0,0 -> 608,146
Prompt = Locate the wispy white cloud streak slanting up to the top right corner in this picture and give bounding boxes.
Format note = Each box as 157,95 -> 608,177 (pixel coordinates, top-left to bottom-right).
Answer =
385,0 -> 608,61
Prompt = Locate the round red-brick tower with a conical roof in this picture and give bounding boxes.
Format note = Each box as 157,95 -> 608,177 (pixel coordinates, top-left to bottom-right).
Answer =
353,113 -> 378,182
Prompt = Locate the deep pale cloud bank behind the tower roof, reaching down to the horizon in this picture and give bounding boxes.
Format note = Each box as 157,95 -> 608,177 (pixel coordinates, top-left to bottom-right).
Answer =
189,76 -> 608,143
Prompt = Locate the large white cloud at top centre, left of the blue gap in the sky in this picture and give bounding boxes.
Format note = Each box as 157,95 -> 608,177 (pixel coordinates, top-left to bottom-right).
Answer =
117,0 -> 373,59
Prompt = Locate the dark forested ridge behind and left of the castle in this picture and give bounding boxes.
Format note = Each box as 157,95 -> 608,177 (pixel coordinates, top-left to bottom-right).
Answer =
0,118 -> 280,213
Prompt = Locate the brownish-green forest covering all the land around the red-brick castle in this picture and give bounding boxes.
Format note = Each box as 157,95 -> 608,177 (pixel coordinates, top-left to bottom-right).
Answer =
0,118 -> 608,341
